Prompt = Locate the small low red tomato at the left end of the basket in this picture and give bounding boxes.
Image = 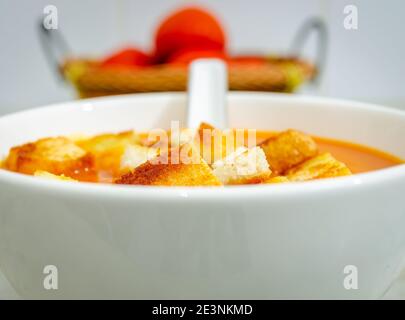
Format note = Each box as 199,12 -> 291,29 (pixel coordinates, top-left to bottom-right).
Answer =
101,48 -> 152,67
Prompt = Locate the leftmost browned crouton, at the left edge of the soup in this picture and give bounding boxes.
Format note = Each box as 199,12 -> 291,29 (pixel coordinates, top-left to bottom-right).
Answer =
5,137 -> 93,181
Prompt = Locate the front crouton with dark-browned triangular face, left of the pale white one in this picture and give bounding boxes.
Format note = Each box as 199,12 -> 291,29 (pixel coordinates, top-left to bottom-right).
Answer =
115,144 -> 221,186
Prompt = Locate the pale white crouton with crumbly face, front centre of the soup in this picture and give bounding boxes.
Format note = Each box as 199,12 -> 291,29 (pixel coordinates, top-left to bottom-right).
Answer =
212,147 -> 271,184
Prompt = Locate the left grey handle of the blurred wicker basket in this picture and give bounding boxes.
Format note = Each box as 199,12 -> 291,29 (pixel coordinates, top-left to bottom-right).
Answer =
38,19 -> 70,80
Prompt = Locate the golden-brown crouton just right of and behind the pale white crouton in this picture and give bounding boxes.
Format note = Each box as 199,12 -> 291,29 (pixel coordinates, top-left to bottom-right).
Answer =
260,130 -> 318,174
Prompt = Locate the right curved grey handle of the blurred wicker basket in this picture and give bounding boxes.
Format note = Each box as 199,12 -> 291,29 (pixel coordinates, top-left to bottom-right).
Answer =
291,17 -> 328,84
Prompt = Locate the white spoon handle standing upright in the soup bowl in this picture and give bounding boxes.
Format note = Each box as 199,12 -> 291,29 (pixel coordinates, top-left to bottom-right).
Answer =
187,59 -> 228,129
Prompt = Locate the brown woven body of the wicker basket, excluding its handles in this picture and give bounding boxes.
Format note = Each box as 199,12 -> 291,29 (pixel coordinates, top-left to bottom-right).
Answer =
61,59 -> 316,98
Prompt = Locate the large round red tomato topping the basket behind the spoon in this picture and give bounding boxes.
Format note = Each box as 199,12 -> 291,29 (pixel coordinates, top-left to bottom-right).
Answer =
155,7 -> 226,62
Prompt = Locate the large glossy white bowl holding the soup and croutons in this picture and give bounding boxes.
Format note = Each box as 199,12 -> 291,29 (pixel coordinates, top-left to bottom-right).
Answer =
0,93 -> 405,299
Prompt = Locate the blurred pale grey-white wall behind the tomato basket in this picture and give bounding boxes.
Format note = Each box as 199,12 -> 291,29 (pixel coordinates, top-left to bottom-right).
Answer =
0,0 -> 405,114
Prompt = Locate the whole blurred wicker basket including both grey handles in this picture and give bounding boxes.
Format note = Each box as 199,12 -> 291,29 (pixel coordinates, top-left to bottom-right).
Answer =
40,18 -> 327,98
